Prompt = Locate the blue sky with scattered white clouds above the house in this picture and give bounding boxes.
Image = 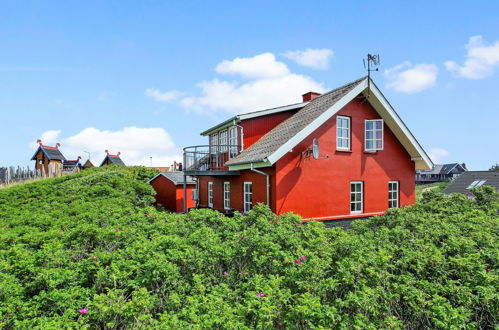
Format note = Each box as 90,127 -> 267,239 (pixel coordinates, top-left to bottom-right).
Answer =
0,0 -> 499,170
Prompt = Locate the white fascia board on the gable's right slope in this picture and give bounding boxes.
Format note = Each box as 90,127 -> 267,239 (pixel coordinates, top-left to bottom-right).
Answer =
369,81 -> 433,170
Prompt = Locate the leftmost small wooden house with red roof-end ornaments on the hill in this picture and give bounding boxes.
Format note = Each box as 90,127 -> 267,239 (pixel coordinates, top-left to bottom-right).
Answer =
31,140 -> 66,177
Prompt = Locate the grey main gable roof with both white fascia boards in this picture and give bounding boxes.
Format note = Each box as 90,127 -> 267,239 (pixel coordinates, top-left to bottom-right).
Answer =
226,77 -> 433,170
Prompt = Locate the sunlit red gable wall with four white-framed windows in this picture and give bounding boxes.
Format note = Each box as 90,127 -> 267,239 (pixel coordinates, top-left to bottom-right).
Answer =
273,99 -> 415,220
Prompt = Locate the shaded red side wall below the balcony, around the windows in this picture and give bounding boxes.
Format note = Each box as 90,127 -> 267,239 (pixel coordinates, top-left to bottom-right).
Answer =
199,167 -> 275,212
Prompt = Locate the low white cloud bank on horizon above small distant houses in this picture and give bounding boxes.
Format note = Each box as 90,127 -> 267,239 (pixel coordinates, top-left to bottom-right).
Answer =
30,127 -> 181,166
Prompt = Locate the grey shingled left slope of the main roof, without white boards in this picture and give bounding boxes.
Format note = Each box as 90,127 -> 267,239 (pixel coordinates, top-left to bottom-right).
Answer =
226,77 -> 365,165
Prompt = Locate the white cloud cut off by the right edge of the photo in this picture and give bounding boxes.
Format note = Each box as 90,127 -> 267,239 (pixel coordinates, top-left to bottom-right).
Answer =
445,36 -> 499,79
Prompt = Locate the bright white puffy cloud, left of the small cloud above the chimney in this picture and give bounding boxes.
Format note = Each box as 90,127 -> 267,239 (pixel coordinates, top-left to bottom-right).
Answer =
215,53 -> 290,78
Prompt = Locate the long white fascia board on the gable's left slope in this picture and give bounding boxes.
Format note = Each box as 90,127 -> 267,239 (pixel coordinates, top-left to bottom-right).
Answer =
267,78 -> 367,165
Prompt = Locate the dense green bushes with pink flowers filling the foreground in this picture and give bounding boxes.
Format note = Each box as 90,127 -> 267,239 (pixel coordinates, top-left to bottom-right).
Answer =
0,166 -> 499,329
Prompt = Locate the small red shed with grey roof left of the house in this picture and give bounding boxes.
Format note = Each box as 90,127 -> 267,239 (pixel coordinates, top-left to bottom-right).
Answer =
149,172 -> 196,212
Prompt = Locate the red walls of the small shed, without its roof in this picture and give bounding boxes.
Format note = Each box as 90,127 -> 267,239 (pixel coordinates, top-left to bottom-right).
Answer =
151,175 -> 195,212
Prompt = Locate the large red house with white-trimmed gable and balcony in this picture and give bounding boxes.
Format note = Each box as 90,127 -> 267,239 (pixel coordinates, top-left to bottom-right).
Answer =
184,77 -> 433,220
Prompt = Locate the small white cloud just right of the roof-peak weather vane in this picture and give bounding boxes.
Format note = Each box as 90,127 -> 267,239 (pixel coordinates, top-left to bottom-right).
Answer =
385,61 -> 438,93
